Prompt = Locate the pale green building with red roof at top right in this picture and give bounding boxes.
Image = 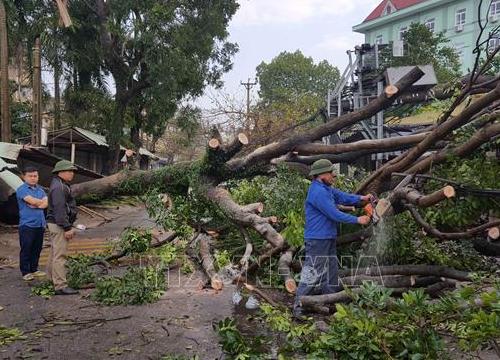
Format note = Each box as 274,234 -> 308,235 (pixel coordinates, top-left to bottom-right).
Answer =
353,0 -> 500,73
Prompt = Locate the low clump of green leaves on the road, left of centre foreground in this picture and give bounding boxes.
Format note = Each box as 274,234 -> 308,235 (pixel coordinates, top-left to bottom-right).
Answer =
91,266 -> 166,305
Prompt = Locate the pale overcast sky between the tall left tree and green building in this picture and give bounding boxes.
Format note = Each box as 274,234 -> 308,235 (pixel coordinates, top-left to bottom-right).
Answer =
198,0 -> 381,108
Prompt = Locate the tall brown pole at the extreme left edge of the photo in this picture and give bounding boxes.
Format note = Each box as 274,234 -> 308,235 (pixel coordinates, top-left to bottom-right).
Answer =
0,0 -> 12,142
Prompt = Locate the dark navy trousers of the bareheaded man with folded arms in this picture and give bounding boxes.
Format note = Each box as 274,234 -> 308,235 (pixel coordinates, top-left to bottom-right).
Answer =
19,225 -> 45,276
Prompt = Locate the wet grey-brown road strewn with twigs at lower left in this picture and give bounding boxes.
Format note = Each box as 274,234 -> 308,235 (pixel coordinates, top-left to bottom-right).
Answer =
0,207 -> 239,359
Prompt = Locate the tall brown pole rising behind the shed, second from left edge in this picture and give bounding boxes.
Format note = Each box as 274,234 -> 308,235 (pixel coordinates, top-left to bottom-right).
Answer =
31,37 -> 42,146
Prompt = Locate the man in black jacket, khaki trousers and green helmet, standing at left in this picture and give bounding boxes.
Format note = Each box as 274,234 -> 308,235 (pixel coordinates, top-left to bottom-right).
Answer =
47,160 -> 78,295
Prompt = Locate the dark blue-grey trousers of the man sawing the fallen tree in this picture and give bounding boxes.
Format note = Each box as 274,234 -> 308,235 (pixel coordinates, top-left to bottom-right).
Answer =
294,239 -> 341,308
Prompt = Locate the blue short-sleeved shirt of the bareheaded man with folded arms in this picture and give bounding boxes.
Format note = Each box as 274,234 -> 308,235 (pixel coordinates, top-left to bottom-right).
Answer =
16,183 -> 47,228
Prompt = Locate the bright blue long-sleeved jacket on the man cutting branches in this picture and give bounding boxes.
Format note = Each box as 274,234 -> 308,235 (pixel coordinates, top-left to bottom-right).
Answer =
304,180 -> 361,240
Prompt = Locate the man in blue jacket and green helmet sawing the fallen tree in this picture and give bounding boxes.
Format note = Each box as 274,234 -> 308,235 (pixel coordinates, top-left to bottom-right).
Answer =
293,159 -> 372,317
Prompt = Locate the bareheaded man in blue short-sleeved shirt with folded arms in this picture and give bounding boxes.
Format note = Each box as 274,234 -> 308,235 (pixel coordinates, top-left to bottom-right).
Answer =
16,166 -> 48,281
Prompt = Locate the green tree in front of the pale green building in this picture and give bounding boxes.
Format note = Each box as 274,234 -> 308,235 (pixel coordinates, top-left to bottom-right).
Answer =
383,23 -> 461,83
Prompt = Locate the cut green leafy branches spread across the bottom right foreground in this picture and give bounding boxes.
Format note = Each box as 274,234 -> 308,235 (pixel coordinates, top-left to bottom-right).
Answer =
219,279 -> 500,359
